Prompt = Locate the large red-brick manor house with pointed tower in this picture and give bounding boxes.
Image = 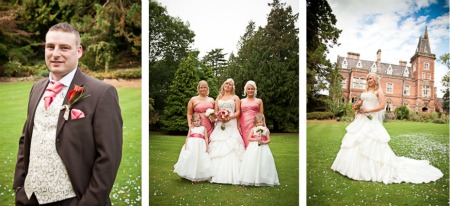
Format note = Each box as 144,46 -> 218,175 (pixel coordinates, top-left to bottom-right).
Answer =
337,28 -> 441,112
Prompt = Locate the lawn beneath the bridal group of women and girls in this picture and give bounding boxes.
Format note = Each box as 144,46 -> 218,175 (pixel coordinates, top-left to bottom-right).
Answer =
149,132 -> 299,205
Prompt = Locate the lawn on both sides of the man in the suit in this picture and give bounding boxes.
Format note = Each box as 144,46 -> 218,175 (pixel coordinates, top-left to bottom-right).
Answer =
0,82 -> 141,205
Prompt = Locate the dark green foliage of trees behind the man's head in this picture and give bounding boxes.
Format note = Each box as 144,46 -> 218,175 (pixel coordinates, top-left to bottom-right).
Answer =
0,0 -> 141,75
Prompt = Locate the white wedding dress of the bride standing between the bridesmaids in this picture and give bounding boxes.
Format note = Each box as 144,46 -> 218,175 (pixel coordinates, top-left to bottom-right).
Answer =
208,100 -> 245,185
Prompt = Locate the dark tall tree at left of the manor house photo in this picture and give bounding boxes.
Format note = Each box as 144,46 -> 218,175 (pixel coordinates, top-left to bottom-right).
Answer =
306,0 -> 341,112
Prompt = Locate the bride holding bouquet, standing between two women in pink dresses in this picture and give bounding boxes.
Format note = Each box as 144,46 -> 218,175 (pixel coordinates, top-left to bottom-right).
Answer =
208,79 -> 245,184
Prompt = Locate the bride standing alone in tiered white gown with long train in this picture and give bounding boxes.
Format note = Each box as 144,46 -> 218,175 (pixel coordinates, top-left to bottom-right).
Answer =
331,73 -> 443,184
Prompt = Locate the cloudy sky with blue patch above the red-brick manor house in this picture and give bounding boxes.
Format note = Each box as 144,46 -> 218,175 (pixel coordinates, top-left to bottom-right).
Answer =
327,0 -> 449,97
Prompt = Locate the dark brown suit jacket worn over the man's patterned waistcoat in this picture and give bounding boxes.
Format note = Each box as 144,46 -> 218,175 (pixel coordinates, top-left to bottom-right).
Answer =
13,69 -> 123,205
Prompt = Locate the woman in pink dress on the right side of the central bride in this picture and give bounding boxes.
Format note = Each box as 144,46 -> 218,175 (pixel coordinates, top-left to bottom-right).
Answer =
239,80 -> 266,148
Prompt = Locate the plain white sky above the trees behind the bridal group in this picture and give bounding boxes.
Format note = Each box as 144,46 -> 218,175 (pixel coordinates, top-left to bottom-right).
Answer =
156,0 -> 299,58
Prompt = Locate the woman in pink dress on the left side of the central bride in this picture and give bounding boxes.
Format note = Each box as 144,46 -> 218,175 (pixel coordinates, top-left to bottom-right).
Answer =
187,80 -> 214,137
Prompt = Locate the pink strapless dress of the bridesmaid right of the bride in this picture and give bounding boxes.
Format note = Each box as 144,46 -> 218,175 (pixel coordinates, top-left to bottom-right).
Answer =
239,101 -> 259,148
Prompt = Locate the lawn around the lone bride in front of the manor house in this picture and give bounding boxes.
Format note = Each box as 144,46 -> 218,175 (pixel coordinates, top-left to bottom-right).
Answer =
306,121 -> 449,205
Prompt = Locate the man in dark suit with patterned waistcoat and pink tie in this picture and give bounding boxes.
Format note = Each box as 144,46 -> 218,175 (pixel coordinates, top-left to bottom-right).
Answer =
13,23 -> 123,205
